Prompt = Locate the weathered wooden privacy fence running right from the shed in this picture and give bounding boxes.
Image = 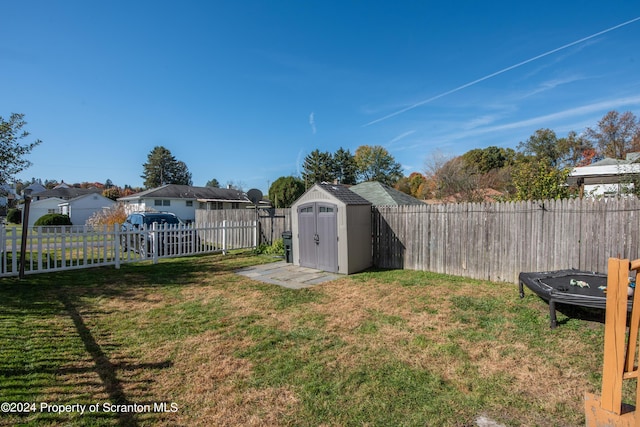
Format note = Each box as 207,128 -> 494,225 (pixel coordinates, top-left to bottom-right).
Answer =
372,198 -> 640,283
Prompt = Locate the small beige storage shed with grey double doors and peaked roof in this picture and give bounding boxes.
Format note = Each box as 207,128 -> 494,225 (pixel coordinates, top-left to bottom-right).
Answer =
291,184 -> 373,274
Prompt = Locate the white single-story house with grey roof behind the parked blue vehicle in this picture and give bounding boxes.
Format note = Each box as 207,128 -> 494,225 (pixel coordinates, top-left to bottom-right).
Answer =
118,184 -> 251,223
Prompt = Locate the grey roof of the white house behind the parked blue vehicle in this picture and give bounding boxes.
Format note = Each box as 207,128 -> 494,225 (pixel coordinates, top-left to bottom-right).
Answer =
118,184 -> 249,203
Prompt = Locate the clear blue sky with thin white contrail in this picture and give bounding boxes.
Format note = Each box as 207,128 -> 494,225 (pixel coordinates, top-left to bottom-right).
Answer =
5,0 -> 640,193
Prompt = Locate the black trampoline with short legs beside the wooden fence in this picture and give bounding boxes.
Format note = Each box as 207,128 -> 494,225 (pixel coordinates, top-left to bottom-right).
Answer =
518,269 -> 633,329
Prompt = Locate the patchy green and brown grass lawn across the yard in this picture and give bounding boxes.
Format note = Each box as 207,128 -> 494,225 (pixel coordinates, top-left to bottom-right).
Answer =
0,253 -> 620,427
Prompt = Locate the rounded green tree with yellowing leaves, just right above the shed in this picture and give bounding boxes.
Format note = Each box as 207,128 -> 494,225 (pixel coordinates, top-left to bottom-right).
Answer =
355,145 -> 403,186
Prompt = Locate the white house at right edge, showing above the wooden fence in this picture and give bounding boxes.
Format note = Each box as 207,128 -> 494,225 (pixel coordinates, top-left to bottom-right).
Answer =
567,153 -> 640,197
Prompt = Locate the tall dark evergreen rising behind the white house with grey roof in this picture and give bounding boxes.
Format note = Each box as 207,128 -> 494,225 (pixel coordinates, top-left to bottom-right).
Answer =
141,147 -> 192,188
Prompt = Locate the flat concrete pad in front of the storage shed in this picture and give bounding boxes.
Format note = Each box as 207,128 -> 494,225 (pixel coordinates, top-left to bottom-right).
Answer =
236,261 -> 342,289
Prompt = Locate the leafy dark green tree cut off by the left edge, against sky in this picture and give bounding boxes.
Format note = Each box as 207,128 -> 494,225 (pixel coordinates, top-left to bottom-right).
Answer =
0,113 -> 42,184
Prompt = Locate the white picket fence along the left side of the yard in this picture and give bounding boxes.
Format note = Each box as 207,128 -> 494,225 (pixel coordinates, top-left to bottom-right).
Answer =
0,221 -> 258,277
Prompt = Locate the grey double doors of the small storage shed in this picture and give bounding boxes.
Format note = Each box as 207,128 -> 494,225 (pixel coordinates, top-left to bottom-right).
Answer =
298,202 -> 338,273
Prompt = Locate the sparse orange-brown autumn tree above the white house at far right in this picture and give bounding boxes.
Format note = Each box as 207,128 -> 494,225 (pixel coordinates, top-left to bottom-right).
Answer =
585,110 -> 640,159
